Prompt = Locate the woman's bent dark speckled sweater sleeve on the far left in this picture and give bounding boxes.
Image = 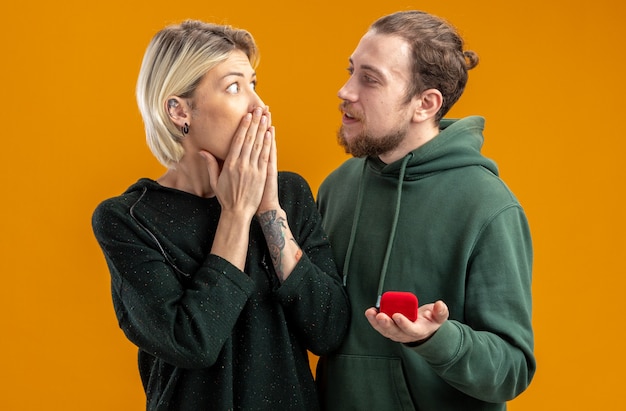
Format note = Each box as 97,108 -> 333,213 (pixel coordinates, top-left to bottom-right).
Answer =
92,198 -> 253,368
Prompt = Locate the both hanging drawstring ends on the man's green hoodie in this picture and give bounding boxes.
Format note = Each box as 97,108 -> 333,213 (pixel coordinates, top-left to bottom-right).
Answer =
343,153 -> 413,308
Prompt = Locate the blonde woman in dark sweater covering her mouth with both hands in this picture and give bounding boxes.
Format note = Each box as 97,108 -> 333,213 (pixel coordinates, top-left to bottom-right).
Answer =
93,21 -> 349,411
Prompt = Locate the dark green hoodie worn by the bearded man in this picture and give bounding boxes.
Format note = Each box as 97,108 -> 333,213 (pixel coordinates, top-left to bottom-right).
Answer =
317,117 -> 535,411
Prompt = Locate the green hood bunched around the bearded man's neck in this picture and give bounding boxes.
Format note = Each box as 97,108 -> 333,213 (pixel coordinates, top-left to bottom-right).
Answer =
367,116 -> 498,180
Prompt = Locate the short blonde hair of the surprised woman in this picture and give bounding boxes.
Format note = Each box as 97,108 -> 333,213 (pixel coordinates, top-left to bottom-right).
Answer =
136,20 -> 259,168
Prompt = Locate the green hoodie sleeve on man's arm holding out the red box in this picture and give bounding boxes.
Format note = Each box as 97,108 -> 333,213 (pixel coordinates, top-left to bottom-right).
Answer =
408,206 -> 536,402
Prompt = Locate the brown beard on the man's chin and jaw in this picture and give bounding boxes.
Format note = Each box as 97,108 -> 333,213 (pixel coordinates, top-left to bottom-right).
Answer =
337,126 -> 407,157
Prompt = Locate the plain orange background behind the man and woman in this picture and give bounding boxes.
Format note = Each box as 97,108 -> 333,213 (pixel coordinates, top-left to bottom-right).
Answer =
0,0 -> 626,411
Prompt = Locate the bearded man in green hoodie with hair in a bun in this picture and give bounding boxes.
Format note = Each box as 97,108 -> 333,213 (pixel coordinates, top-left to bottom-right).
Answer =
317,11 -> 535,411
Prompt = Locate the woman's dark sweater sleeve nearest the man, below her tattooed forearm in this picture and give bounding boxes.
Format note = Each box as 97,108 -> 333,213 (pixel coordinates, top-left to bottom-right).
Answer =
276,173 -> 350,355
